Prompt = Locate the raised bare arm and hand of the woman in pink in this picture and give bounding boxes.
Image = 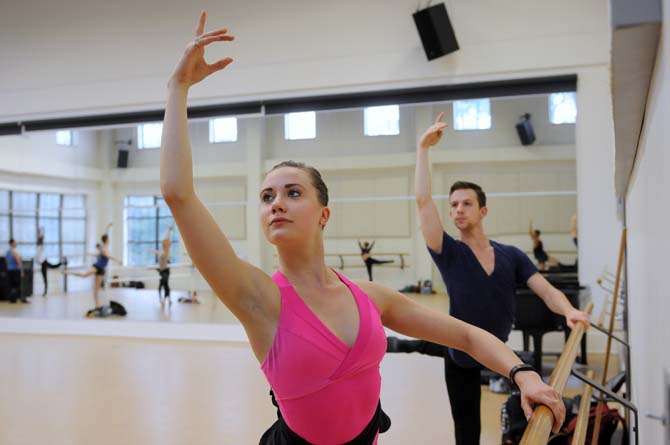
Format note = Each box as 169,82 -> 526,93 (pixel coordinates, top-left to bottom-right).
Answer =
160,11 -> 279,330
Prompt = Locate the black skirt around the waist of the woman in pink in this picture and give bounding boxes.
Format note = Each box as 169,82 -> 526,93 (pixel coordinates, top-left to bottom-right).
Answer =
259,391 -> 391,445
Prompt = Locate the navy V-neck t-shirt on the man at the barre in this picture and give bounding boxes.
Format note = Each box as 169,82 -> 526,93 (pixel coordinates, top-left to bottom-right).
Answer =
428,232 -> 537,368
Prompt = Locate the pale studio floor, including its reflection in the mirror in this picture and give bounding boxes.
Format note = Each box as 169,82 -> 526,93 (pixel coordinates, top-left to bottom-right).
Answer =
0,288 -> 615,445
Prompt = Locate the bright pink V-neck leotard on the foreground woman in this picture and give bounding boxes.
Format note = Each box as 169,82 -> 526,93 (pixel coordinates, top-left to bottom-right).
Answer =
261,271 -> 386,445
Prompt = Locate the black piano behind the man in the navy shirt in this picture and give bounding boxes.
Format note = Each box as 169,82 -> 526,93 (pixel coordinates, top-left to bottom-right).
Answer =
513,268 -> 590,371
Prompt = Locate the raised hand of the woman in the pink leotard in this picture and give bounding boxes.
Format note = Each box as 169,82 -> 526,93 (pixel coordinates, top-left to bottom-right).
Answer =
168,11 -> 235,89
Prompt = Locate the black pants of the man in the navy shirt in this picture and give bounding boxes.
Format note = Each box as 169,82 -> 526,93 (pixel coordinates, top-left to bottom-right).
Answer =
400,341 -> 482,445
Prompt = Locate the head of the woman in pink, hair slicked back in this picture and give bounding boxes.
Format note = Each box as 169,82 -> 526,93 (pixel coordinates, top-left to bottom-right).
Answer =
259,167 -> 330,245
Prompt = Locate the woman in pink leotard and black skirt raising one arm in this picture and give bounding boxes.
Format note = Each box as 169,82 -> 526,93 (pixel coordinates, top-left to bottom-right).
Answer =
160,12 -> 565,445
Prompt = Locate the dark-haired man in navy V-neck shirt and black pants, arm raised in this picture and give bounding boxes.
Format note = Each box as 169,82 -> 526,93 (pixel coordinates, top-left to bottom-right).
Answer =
389,113 -> 589,445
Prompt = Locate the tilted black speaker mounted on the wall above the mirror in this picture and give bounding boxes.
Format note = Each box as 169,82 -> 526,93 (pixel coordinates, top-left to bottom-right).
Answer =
414,3 -> 458,60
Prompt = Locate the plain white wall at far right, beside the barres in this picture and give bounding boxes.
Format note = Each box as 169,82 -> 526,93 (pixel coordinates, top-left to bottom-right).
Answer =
626,0 -> 670,438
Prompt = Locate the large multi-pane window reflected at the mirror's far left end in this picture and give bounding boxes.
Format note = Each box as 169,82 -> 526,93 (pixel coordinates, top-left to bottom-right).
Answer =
0,190 -> 86,267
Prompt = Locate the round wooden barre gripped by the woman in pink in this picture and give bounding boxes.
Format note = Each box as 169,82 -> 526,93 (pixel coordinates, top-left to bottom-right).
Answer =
519,303 -> 593,445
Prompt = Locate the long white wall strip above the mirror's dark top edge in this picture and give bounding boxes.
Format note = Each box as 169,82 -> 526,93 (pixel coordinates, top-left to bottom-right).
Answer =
0,0 -> 609,122
